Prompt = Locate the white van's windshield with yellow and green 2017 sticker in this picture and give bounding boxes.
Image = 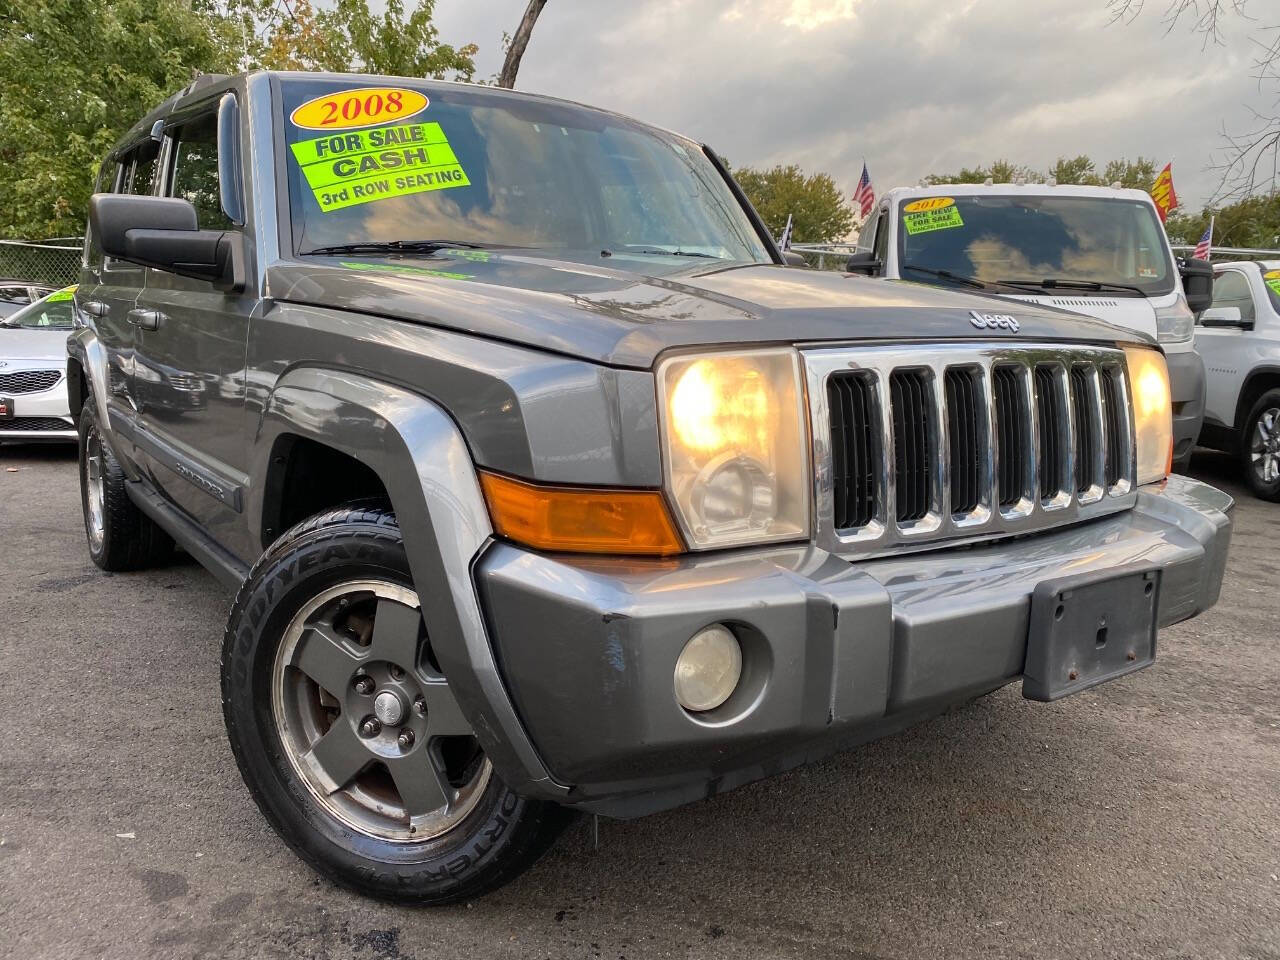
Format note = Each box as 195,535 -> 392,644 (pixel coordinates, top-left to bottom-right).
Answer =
899,193 -> 1174,296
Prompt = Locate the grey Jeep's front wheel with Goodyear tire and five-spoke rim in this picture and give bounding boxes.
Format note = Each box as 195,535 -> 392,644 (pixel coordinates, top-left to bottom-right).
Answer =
223,503 -> 567,904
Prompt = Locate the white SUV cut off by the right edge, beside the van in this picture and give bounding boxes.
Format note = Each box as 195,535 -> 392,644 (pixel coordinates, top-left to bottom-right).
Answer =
1196,260 -> 1280,500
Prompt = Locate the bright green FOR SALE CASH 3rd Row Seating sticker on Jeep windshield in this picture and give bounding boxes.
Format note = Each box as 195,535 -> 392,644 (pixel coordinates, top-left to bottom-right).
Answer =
292,123 -> 471,214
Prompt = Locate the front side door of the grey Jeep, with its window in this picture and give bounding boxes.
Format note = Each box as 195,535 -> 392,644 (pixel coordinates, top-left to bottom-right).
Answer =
133,93 -> 256,552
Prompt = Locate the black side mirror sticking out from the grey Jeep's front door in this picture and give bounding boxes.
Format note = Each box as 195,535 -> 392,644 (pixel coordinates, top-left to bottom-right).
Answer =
88,193 -> 244,291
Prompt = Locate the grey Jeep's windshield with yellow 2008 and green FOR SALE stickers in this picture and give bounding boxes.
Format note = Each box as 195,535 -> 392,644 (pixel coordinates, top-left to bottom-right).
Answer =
282,79 -> 769,270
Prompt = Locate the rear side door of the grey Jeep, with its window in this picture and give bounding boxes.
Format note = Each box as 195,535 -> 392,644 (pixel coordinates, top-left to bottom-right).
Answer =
76,138 -> 160,460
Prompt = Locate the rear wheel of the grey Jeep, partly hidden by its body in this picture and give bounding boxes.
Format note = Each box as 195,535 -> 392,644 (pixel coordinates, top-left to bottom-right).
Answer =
79,402 -> 173,571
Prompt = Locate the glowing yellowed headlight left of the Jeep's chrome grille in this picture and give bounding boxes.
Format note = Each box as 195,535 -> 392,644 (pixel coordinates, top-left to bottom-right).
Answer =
658,349 -> 809,549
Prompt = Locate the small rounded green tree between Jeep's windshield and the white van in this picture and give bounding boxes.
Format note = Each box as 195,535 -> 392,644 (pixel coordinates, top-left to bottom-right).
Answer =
733,164 -> 854,243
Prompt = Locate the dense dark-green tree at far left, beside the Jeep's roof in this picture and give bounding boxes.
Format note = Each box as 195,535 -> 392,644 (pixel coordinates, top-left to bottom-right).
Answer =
0,0 -> 234,238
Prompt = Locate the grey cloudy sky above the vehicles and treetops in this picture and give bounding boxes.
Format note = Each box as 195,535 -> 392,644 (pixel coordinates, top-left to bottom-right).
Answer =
436,0 -> 1274,209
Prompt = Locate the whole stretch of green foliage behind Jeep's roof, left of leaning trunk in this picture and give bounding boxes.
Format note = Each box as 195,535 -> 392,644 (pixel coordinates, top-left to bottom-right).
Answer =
0,0 -> 476,239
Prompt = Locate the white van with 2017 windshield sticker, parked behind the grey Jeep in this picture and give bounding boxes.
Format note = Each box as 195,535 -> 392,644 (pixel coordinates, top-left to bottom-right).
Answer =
849,183 -> 1212,468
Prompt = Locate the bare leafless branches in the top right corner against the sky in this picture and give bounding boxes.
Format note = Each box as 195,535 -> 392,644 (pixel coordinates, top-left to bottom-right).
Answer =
1107,0 -> 1280,200
